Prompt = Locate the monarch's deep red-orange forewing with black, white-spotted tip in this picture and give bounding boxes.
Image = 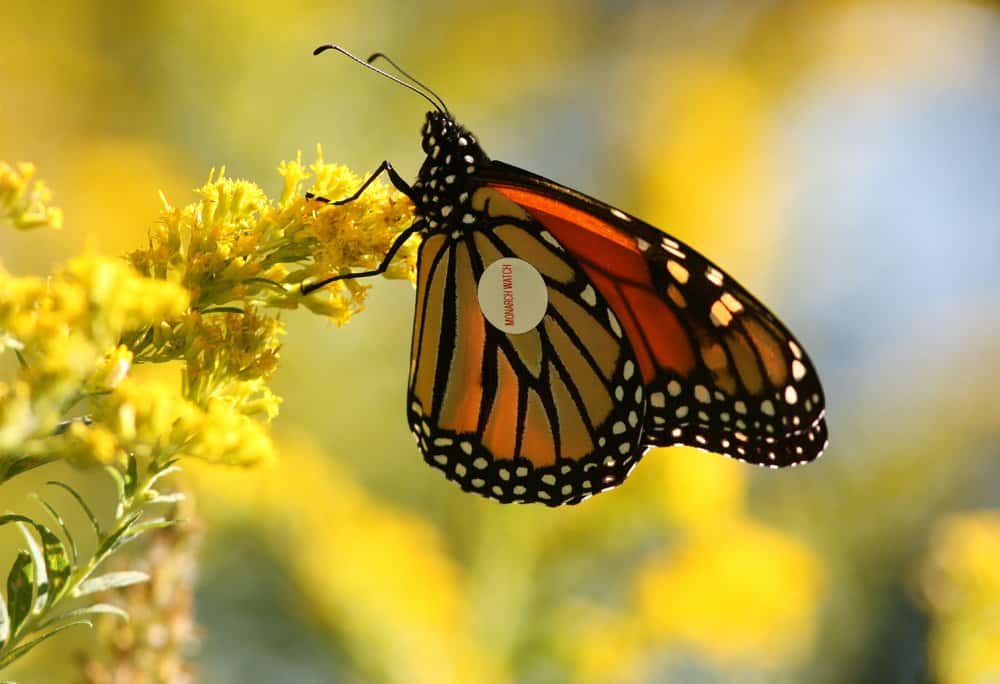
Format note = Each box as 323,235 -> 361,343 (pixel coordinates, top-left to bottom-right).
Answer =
478,162 -> 827,467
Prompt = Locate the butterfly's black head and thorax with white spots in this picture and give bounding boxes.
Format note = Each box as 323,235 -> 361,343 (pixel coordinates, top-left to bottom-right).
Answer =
413,111 -> 489,233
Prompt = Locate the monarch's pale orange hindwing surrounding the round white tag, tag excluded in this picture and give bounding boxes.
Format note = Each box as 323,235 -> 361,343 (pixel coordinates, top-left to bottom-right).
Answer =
407,188 -> 646,505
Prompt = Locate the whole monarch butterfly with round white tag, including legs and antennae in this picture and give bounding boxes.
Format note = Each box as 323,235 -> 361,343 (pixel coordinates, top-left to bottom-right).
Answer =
302,45 -> 827,506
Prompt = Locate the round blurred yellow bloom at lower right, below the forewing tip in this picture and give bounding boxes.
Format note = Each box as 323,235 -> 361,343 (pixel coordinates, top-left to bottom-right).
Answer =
634,520 -> 822,667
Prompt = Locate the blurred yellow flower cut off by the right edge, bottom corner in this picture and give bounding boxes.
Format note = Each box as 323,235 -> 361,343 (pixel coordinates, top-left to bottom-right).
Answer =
918,511 -> 1000,684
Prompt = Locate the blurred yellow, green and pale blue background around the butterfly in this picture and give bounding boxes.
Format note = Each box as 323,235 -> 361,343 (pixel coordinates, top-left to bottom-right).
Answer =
0,0 -> 1000,684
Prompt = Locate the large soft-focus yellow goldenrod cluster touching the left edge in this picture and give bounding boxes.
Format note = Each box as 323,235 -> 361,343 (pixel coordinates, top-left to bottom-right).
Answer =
0,256 -> 188,472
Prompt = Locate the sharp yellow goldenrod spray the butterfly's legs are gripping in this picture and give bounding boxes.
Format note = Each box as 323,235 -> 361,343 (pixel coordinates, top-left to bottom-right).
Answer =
129,150 -> 416,324
